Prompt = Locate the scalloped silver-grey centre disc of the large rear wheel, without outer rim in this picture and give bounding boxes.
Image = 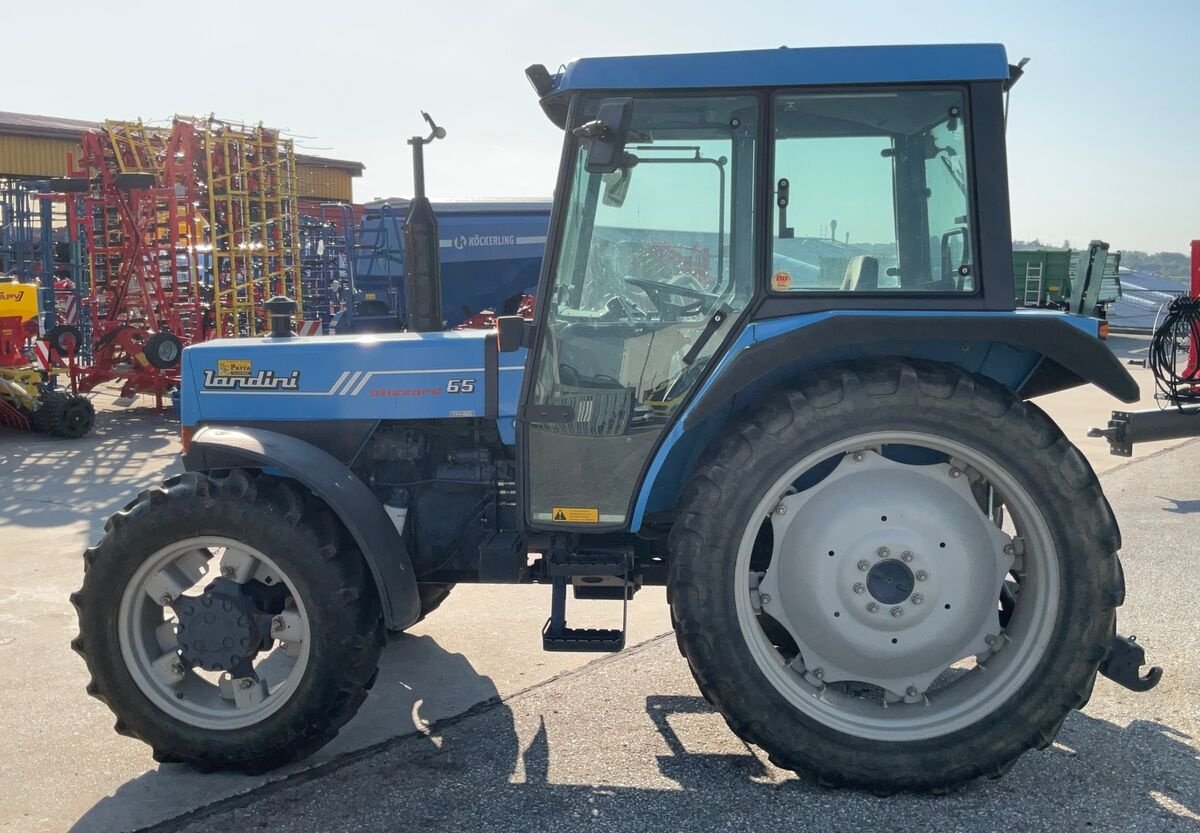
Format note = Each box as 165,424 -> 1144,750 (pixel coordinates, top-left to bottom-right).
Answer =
758,450 -> 1013,701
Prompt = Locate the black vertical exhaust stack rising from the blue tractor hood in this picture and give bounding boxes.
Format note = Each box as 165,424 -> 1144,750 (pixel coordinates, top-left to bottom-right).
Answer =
404,110 -> 446,332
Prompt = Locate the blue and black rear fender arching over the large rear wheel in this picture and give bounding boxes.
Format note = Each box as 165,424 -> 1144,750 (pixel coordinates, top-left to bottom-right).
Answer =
631,311 -> 1140,531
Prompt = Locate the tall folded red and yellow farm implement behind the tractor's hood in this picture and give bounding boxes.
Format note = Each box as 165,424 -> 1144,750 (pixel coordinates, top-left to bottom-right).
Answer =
47,118 -> 301,407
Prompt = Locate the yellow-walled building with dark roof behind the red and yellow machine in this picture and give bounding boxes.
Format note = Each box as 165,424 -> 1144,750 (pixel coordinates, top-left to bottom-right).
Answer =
0,112 -> 362,202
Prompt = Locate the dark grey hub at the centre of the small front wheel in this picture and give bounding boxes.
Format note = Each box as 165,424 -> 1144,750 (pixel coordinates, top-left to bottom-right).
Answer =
173,579 -> 271,677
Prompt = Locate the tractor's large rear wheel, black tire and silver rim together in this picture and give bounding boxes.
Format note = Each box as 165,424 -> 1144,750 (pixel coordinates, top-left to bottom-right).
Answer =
670,361 -> 1121,792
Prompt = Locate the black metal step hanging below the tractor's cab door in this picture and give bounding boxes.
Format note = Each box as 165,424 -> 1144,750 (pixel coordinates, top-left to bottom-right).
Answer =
541,547 -> 636,653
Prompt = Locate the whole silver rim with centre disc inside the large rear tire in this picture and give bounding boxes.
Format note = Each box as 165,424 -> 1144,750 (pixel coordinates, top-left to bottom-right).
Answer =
734,431 -> 1060,742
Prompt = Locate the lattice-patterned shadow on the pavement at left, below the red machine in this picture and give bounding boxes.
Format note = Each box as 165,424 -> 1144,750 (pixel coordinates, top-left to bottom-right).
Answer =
0,408 -> 181,540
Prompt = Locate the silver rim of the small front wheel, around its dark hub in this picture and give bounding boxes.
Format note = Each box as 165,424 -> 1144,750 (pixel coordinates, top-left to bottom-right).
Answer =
116,537 -> 312,730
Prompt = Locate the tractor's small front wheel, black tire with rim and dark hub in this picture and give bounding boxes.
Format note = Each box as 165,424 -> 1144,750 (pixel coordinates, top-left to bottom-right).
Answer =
72,471 -> 383,772
